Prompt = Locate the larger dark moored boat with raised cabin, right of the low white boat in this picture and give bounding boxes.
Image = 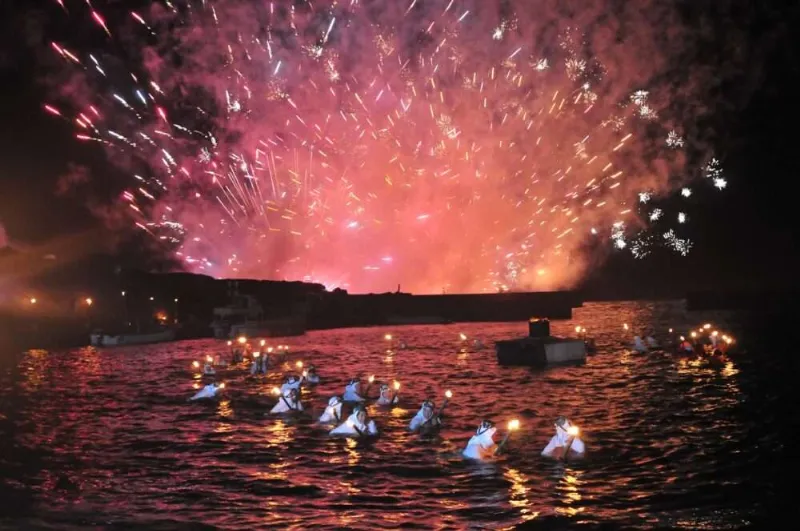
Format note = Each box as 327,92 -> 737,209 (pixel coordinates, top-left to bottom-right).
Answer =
211,290 -> 306,339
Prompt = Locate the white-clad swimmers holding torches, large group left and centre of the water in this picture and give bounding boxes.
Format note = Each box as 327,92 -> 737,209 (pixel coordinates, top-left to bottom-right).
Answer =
190,353 -> 585,460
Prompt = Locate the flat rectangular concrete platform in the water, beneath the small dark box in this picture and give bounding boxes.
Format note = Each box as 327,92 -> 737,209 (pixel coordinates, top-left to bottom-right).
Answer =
495,336 -> 586,367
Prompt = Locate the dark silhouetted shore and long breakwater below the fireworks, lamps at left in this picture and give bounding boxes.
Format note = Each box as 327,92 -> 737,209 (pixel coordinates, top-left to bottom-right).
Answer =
0,251 -> 582,347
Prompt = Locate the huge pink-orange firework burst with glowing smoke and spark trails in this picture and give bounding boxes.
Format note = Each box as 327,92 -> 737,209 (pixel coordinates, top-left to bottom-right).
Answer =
40,0 -> 727,292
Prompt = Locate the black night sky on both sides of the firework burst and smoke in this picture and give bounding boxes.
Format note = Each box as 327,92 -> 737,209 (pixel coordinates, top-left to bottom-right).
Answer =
0,0 -> 800,292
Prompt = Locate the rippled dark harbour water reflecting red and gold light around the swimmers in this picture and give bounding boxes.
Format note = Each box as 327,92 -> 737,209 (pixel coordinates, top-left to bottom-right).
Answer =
0,303 -> 785,529
